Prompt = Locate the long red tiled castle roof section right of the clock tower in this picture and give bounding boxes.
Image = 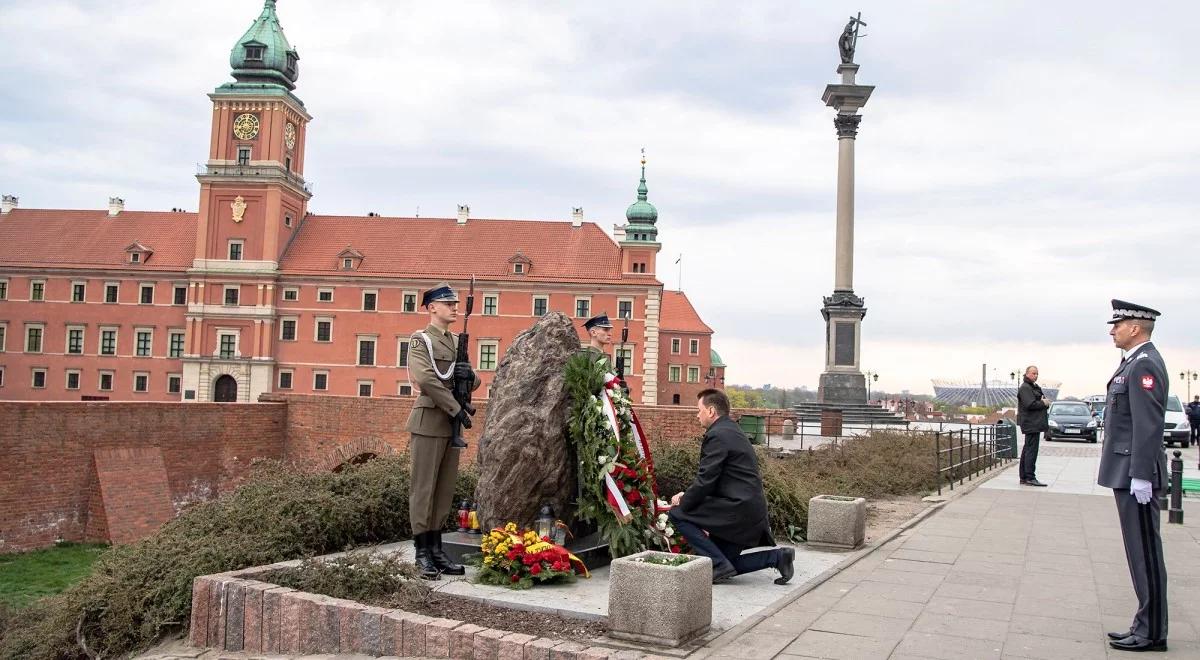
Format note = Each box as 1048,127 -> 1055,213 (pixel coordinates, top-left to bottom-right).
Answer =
280,215 -> 656,283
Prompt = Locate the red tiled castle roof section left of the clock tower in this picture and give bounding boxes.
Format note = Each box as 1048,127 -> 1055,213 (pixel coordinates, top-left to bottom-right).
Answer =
0,209 -> 196,270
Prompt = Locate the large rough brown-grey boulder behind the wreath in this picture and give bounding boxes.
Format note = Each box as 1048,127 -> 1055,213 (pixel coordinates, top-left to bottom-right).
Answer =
475,312 -> 580,529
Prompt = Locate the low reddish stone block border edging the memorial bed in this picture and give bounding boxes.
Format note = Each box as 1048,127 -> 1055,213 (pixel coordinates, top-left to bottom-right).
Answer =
188,562 -> 629,660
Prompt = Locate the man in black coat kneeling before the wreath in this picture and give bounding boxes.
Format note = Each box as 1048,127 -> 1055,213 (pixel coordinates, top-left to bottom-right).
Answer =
667,390 -> 796,584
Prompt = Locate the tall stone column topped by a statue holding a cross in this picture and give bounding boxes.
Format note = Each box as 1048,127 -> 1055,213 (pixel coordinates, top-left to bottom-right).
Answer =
817,48 -> 875,404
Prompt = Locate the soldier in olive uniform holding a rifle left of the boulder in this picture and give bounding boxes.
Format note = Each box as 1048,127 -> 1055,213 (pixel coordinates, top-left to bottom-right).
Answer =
407,282 -> 480,580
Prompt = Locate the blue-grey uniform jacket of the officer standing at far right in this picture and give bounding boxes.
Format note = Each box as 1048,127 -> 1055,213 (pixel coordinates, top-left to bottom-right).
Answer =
1097,343 -> 1166,490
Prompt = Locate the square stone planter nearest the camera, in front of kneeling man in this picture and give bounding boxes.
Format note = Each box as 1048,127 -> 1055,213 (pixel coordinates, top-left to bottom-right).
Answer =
608,551 -> 713,647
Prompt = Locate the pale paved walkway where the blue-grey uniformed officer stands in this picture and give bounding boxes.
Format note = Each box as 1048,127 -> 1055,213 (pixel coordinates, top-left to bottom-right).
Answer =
707,445 -> 1200,660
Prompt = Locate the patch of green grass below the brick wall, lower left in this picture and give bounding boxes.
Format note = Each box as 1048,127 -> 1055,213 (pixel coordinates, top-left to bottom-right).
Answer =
0,544 -> 107,607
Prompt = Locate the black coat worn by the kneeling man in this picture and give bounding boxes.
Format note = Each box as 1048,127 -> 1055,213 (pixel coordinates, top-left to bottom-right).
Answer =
676,416 -> 775,547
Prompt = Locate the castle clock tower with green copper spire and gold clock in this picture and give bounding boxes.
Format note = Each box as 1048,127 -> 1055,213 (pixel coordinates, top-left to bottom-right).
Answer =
184,0 -> 312,402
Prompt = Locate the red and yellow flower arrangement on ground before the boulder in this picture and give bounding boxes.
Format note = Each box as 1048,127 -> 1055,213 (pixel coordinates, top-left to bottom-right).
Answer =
473,522 -> 589,589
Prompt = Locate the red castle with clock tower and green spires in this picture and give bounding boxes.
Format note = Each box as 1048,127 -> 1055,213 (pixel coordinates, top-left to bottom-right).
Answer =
0,0 -> 724,406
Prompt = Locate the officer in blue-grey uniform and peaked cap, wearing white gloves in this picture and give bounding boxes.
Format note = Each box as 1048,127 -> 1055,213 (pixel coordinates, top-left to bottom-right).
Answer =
1097,300 -> 1168,650
